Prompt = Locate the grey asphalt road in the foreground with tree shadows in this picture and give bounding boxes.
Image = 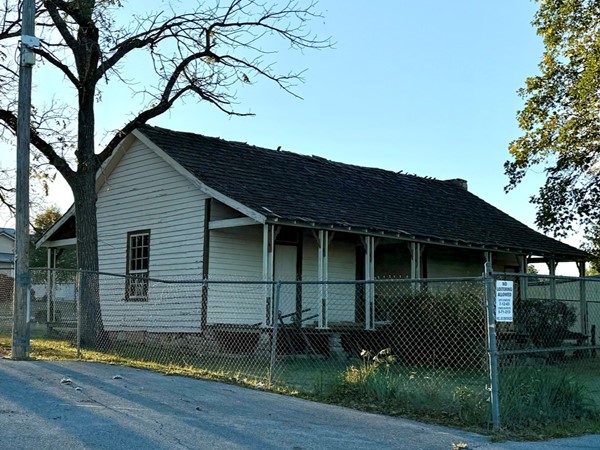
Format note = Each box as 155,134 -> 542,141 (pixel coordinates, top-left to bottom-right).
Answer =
0,360 -> 600,450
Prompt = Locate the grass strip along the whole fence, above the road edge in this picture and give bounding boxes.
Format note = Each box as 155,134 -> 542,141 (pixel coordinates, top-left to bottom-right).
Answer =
0,337 -> 600,440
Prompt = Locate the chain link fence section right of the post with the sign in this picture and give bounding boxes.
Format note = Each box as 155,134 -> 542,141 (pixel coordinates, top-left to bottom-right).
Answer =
494,274 -> 600,428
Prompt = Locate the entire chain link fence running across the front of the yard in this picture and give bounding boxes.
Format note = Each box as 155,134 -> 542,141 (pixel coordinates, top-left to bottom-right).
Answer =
0,270 -> 600,429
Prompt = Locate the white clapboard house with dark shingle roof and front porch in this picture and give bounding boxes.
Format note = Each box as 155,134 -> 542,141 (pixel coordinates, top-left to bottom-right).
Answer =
38,126 -> 589,333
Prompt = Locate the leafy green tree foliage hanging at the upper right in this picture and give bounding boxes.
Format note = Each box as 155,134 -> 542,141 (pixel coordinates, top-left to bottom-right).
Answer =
505,0 -> 600,236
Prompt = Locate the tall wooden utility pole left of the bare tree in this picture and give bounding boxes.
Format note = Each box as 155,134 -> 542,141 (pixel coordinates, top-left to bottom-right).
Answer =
12,0 -> 39,360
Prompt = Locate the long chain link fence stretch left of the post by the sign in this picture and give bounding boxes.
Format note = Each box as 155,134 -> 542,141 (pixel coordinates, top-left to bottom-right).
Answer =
16,270 -> 489,425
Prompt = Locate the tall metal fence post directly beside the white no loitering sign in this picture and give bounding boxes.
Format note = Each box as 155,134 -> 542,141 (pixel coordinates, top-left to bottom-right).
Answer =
483,262 -> 500,431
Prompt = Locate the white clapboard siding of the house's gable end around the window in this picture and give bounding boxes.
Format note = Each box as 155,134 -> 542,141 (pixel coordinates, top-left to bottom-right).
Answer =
98,141 -> 206,332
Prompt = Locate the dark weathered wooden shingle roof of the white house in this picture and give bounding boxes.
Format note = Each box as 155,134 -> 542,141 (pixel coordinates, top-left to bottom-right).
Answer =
139,126 -> 589,260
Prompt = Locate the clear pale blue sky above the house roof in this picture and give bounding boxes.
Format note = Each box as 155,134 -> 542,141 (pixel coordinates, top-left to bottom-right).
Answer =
3,0 -> 578,268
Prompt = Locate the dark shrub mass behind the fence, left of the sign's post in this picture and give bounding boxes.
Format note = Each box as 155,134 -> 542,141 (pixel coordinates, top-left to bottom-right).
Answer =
341,289 -> 486,369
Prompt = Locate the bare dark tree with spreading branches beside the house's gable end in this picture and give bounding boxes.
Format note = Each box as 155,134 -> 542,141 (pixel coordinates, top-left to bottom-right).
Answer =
0,0 -> 330,345
